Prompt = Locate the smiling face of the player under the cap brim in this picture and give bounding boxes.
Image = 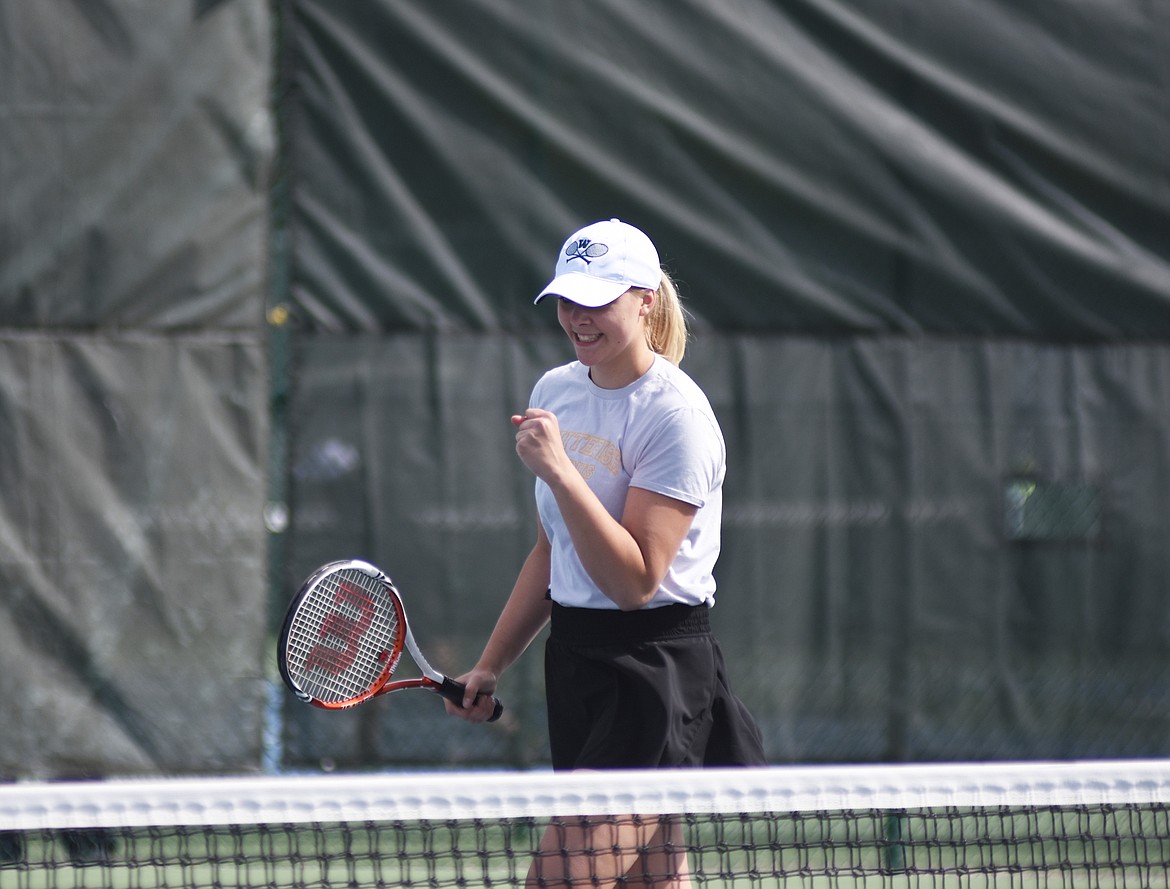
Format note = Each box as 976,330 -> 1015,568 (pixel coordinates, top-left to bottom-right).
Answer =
557,289 -> 654,388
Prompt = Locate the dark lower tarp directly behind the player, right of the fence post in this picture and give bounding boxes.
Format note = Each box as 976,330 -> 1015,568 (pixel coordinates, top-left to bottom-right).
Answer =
284,332 -> 1170,766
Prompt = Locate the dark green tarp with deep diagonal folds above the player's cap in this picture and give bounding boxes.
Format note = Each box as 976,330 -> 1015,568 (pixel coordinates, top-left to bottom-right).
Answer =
283,0 -> 1170,340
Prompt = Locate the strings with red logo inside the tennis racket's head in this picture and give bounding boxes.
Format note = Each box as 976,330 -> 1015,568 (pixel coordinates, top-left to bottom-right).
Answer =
285,570 -> 402,704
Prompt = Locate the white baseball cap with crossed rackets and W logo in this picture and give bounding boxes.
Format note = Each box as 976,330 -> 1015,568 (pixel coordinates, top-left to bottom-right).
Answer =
534,219 -> 662,309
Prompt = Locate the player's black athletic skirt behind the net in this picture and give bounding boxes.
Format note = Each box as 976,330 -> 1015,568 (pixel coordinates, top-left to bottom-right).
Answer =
544,604 -> 766,770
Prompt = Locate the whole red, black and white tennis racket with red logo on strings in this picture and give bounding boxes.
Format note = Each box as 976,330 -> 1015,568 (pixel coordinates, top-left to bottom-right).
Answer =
276,559 -> 504,722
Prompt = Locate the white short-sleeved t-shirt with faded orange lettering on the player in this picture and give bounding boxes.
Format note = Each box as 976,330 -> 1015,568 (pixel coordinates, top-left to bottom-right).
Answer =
530,357 -> 727,609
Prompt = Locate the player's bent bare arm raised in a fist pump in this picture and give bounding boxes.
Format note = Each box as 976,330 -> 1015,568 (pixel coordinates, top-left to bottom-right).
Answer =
512,409 -> 697,611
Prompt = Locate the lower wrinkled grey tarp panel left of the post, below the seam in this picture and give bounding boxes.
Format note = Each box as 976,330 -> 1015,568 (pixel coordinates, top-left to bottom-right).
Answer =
0,333 -> 267,778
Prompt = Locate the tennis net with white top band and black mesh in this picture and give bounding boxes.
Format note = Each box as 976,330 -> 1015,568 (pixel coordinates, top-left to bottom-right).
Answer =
0,760 -> 1170,889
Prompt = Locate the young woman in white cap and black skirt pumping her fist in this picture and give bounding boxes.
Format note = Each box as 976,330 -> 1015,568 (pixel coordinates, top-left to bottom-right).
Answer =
447,219 -> 765,887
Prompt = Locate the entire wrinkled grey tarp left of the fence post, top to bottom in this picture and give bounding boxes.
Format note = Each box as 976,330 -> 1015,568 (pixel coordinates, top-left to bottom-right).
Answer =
0,0 -> 275,779
